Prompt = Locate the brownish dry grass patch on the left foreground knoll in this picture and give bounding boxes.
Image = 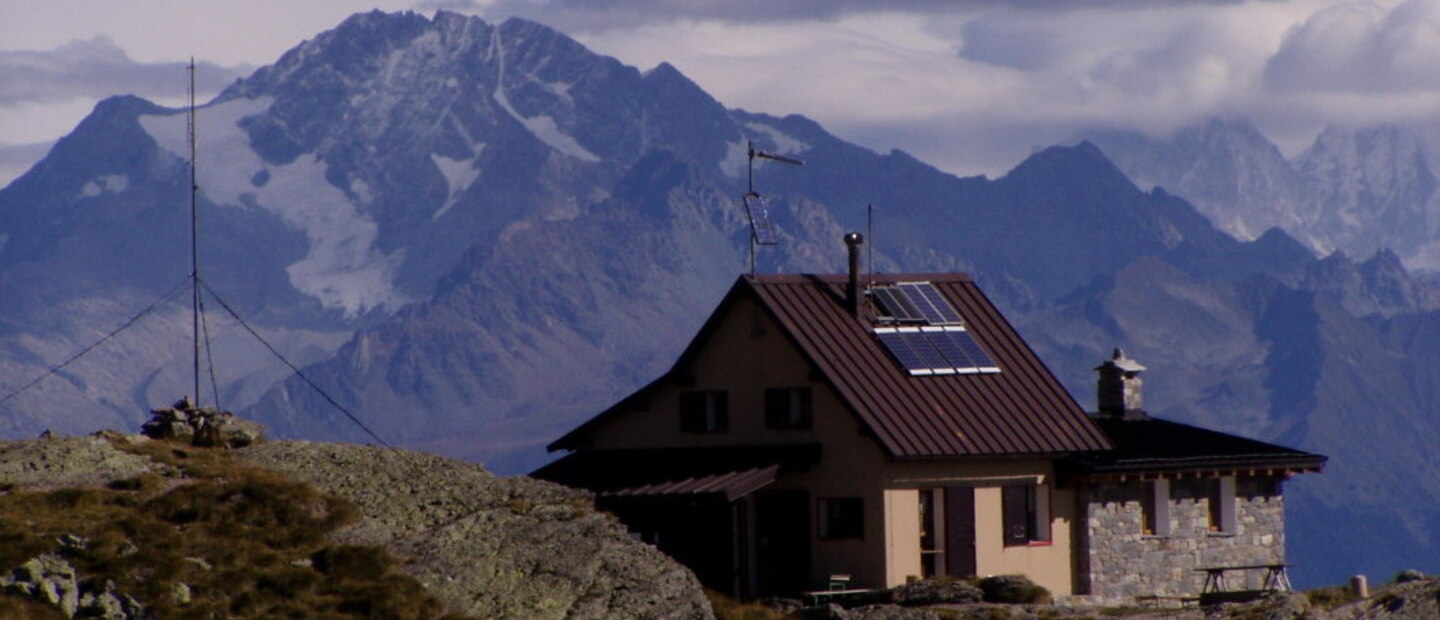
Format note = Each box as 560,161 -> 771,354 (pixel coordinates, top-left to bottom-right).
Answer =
0,442 -> 480,620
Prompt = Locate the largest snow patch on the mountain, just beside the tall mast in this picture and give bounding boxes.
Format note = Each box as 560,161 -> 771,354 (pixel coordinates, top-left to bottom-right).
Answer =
140,98 -> 409,316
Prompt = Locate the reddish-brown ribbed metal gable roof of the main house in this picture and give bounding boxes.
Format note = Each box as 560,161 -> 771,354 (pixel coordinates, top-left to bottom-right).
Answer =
549,273 -> 1110,459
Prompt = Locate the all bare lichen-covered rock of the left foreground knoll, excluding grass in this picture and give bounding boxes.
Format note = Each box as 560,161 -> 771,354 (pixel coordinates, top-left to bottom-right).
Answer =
0,433 -> 714,620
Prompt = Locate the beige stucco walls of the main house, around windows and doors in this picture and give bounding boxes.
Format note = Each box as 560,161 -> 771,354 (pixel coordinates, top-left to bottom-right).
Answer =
578,299 -> 1074,594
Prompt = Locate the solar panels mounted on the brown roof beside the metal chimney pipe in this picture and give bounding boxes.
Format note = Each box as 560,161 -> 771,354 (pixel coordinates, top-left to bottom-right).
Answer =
870,282 -> 999,375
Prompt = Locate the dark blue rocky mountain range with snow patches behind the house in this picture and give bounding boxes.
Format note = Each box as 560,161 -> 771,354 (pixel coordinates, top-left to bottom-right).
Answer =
0,12 -> 1440,592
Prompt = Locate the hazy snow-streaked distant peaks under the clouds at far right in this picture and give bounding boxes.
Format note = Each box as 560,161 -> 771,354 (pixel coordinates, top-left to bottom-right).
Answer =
1081,119 -> 1440,272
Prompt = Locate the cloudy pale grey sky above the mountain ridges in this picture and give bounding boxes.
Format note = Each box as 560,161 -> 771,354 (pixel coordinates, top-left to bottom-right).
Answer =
0,0 -> 1440,184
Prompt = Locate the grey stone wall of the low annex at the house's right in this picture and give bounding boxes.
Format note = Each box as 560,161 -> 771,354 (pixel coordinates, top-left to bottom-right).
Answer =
1076,476 -> 1284,598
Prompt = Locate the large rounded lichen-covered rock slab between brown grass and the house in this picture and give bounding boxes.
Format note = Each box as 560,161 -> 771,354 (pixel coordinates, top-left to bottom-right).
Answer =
238,442 -> 713,620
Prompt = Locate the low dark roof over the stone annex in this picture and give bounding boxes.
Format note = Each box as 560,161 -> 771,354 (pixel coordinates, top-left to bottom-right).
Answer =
1064,416 -> 1328,475
